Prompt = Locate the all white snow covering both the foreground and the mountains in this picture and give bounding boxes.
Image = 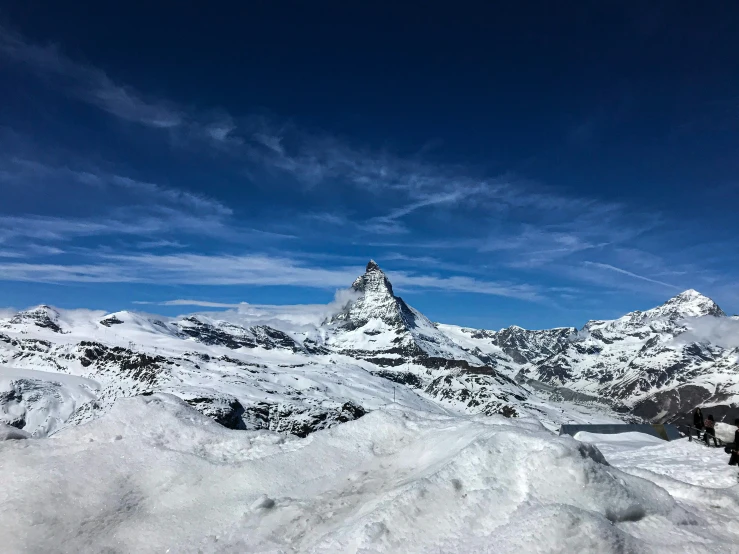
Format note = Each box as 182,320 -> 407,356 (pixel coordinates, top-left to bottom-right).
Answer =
0,263 -> 739,553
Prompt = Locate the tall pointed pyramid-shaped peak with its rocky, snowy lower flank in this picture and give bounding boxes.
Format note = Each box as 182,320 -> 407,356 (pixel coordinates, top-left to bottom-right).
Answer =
322,260 -> 600,419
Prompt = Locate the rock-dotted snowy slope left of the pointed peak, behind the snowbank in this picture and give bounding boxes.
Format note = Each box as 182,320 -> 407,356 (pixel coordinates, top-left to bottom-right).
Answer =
0,306 -> 446,435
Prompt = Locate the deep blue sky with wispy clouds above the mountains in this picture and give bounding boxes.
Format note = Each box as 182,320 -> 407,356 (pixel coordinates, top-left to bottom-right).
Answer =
0,1 -> 739,328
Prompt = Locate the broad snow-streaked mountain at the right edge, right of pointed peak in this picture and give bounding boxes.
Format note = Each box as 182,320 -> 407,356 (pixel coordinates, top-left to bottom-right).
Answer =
522,290 -> 739,422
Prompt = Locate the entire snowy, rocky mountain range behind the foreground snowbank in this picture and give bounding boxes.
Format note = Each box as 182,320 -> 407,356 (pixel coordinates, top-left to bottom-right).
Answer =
0,261 -> 739,436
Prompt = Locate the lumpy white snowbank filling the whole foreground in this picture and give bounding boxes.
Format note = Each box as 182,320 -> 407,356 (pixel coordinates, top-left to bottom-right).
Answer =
0,394 -> 739,553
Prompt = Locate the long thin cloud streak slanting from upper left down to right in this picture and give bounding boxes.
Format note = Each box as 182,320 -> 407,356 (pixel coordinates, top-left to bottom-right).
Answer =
0,21 -> 652,252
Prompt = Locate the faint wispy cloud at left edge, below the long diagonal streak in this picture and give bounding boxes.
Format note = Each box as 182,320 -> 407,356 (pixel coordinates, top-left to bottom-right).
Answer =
0,157 -> 292,249
